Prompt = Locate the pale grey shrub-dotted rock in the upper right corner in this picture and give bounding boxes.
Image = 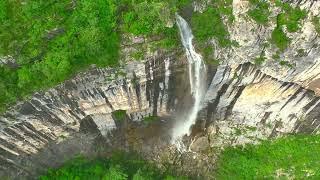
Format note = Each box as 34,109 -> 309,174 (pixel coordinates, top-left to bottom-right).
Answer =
199,0 -> 320,92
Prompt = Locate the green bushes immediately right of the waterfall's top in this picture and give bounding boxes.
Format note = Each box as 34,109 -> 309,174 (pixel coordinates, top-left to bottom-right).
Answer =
191,7 -> 232,47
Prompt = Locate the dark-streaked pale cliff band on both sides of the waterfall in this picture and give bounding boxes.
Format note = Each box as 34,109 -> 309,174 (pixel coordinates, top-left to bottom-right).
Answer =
0,54 -> 320,176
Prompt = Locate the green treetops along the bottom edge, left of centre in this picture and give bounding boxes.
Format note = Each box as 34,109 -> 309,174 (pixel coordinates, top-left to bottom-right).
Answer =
40,153 -> 187,180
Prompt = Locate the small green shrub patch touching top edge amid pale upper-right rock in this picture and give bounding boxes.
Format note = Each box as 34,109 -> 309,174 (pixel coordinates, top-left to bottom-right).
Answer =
248,0 -> 271,25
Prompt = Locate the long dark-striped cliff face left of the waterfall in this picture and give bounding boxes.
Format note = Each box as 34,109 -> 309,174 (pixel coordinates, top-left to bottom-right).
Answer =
0,50 -> 188,177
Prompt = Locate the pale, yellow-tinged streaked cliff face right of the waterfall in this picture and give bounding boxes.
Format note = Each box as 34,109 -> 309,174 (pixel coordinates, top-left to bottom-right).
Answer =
200,63 -> 320,146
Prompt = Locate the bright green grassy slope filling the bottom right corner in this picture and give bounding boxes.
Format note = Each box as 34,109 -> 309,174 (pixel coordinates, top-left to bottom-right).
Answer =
216,135 -> 320,179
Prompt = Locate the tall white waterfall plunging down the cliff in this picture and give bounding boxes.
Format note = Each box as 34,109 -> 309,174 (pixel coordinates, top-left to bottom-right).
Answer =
172,15 -> 206,148
